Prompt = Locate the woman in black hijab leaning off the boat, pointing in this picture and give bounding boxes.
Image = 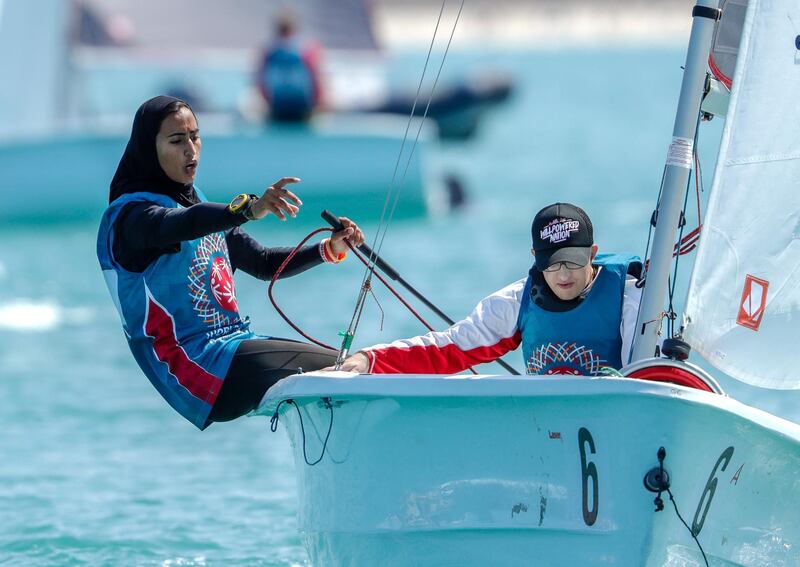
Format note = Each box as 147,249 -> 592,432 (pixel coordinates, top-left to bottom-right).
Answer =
97,96 -> 364,429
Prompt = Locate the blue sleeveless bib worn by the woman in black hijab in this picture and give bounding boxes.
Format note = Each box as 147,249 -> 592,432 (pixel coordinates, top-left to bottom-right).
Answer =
97,192 -> 255,429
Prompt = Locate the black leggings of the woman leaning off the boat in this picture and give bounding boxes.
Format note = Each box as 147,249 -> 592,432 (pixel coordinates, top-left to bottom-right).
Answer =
208,339 -> 337,421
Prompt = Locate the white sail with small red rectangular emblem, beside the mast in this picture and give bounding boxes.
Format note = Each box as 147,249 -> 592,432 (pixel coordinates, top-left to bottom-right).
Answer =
684,0 -> 800,389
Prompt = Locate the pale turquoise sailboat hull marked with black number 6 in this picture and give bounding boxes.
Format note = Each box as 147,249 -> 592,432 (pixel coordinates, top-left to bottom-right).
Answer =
259,374 -> 800,566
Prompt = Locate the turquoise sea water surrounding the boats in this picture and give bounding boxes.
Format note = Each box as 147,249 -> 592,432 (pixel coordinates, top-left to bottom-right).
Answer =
0,47 -> 800,566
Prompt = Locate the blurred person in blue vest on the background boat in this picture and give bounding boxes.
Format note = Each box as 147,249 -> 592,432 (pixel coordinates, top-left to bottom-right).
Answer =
256,13 -> 322,122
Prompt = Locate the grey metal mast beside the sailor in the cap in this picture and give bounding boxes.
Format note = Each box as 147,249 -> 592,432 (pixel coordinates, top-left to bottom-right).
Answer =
631,0 -> 721,362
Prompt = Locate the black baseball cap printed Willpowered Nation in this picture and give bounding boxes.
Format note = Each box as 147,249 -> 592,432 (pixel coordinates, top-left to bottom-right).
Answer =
531,203 -> 594,271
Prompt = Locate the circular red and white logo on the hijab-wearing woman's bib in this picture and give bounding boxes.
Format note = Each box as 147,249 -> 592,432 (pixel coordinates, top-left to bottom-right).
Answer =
188,233 -> 239,329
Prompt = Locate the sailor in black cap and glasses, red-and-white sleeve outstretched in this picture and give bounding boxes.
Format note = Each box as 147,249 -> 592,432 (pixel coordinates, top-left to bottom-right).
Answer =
341,203 -> 642,376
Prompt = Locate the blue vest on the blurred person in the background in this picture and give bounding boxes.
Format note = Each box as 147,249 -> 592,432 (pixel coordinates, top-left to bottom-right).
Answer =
263,40 -> 314,119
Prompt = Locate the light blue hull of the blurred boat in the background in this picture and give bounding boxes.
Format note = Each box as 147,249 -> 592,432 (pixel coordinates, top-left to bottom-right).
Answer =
0,115 -> 440,223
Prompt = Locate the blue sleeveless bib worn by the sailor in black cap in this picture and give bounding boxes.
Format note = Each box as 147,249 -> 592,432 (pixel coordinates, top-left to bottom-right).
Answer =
517,254 -> 639,376
